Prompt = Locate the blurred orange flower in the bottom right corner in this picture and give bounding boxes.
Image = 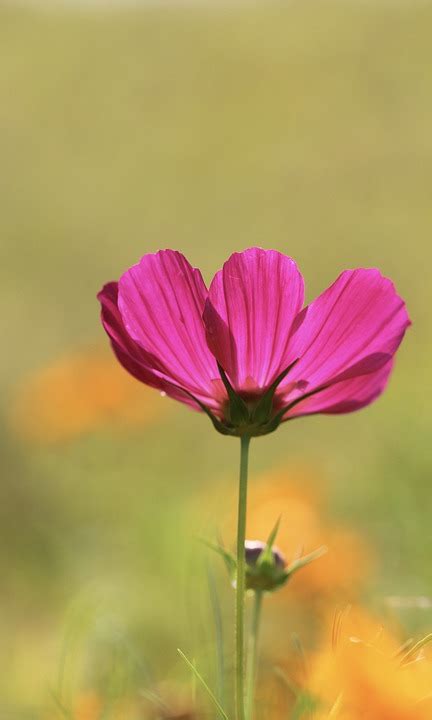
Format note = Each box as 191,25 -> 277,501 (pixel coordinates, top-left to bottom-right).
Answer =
307,610 -> 432,720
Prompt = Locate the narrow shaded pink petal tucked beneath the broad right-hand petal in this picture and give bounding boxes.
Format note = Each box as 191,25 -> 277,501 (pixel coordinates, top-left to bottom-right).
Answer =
284,360 -> 393,420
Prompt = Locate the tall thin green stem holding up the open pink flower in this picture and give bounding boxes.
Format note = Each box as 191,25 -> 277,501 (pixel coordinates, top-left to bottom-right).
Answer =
236,435 -> 250,720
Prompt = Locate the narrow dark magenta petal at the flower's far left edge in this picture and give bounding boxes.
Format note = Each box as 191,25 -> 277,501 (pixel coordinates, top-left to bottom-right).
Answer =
97,282 -> 198,409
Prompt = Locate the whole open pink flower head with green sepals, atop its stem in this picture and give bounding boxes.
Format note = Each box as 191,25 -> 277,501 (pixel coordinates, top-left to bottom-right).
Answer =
98,248 -> 410,435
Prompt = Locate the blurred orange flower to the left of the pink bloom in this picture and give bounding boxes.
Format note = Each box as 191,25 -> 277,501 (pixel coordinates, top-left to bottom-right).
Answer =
10,348 -> 166,443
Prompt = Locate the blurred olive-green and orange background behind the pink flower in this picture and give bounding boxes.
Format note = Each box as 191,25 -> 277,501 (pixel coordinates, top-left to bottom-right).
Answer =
0,0 -> 432,720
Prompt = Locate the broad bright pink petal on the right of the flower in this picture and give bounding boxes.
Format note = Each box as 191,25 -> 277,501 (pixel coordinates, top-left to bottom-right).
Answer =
281,269 -> 410,395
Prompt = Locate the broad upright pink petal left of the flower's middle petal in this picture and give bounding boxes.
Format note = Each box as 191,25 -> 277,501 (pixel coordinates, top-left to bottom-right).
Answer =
118,250 -> 221,404
